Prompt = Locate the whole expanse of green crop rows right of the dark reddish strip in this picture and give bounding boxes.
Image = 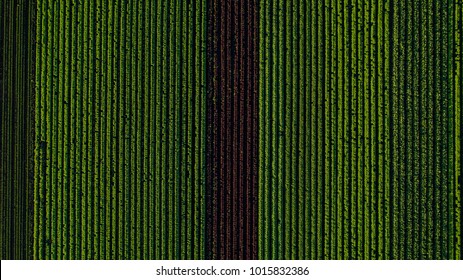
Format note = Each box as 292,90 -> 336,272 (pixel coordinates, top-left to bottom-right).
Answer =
259,0 -> 462,259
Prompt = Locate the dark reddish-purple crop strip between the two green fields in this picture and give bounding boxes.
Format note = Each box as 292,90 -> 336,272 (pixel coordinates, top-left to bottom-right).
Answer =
206,0 -> 258,259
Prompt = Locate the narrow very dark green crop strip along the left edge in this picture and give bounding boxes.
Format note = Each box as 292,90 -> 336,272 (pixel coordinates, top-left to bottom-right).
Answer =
0,0 -> 36,259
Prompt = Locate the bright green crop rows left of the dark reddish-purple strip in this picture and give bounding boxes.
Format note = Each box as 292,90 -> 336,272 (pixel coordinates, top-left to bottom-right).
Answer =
33,0 -> 205,259
